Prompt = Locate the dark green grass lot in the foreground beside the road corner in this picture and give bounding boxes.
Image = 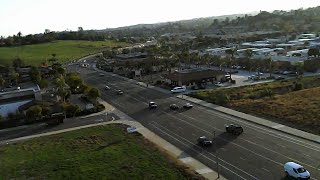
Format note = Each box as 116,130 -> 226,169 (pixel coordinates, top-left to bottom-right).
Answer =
0,124 -> 202,180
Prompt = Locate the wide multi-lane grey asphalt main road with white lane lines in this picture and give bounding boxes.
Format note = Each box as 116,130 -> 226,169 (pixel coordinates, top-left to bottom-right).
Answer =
70,61 -> 320,180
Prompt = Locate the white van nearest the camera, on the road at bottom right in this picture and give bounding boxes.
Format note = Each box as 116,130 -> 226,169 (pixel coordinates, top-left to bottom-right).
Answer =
284,162 -> 310,179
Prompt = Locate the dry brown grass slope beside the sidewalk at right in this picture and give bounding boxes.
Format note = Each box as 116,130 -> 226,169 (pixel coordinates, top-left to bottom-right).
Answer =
229,87 -> 320,134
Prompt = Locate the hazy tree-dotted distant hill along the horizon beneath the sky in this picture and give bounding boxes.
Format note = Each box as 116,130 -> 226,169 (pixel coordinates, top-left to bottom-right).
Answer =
100,6 -> 320,37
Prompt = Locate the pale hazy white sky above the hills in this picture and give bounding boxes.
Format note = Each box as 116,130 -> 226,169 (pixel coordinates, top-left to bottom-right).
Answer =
0,0 -> 320,36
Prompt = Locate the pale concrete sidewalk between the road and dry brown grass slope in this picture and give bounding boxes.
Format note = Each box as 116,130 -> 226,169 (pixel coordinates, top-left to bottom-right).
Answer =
177,95 -> 320,143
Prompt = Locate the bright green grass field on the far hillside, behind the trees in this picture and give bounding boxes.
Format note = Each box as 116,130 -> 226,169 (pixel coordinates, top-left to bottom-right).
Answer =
0,40 -> 127,65
